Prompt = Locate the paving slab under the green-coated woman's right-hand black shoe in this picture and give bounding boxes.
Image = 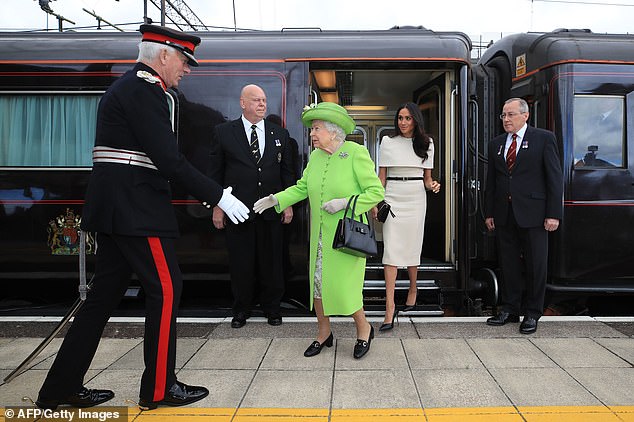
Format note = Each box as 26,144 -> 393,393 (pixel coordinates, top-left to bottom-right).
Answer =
336,338 -> 408,370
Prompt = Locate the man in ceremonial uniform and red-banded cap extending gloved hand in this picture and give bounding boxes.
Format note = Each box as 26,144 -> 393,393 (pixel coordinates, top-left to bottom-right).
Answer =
36,25 -> 249,409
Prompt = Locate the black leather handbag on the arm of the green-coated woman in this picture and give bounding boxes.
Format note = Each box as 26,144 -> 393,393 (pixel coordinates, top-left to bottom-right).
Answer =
332,195 -> 377,258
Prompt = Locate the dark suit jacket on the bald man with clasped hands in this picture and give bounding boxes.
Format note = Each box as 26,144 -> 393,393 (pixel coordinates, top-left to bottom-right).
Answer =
211,118 -> 296,220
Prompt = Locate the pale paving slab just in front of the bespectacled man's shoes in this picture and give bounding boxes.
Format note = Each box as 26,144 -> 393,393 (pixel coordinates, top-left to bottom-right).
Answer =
466,337 -> 556,368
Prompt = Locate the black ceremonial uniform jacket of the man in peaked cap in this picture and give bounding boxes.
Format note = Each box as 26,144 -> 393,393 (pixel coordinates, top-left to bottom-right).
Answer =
81,63 -> 222,237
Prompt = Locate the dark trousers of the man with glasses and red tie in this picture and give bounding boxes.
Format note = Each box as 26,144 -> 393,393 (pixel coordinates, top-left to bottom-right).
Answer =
495,204 -> 548,318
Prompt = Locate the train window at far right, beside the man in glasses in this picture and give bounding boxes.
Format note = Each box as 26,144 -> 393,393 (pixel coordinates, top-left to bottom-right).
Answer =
573,95 -> 625,170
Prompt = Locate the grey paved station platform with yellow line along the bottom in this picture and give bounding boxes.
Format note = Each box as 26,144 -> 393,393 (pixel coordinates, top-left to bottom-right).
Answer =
0,317 -> 634,422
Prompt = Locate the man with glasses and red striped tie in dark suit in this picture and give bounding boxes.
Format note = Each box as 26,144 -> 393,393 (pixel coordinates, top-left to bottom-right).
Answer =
485,98 -> 563,334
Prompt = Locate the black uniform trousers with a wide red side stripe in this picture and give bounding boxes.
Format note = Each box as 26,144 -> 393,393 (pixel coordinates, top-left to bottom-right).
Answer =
40,233 -> 183,401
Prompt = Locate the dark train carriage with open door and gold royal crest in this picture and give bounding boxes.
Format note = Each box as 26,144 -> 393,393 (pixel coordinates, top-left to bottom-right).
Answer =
0,28 -> 471,314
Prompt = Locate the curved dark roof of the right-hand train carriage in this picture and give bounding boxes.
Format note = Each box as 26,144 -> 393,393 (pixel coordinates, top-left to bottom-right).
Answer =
478,29 -> 634,74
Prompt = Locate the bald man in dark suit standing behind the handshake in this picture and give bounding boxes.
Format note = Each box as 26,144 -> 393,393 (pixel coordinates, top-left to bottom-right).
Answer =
211,85 -> 296,328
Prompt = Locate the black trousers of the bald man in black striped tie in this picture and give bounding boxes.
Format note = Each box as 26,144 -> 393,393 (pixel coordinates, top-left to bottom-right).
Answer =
226,216 -> 284,315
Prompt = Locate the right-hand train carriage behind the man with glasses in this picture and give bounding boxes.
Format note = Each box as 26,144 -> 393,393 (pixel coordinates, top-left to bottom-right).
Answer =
469,29 -> 634,295
